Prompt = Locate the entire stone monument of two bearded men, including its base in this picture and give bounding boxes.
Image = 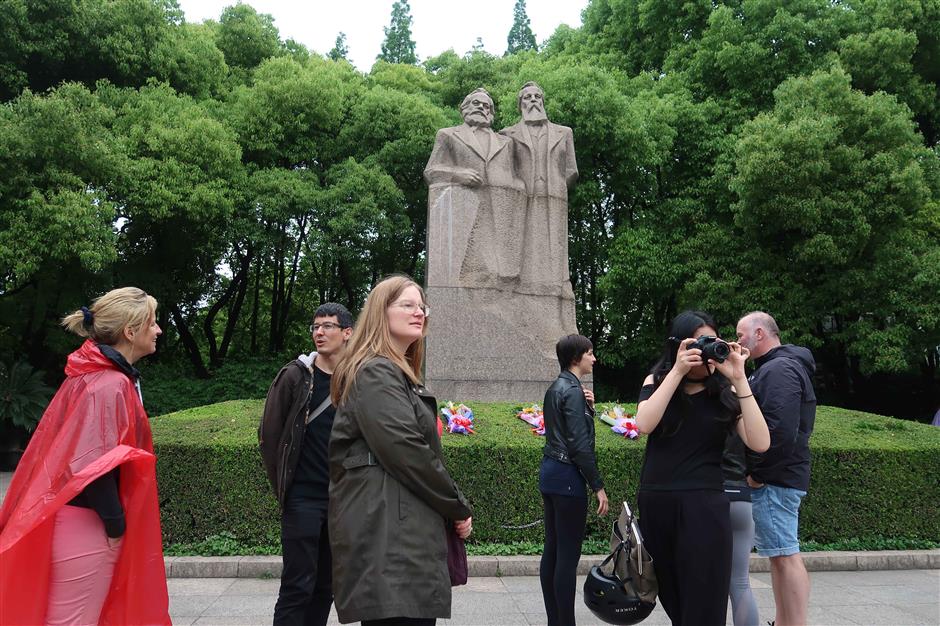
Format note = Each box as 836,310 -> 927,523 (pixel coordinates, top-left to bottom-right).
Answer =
424,83 -> 578,401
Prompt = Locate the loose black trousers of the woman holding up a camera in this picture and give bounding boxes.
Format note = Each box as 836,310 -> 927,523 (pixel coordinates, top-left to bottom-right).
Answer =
637,491 -> 731,626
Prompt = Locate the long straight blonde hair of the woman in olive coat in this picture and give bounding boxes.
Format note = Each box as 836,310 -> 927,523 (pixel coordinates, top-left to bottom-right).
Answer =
330,275 -> 428,406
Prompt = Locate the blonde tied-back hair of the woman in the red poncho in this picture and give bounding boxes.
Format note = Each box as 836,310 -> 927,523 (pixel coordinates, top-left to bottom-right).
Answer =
62,287 -> 157,346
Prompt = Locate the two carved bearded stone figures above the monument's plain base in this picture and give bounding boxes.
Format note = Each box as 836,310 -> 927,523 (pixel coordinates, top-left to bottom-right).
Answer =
424,82 -> 578,299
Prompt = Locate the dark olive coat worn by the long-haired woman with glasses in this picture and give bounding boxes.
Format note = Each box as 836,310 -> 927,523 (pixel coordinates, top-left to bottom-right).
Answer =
329,357 -> 471,624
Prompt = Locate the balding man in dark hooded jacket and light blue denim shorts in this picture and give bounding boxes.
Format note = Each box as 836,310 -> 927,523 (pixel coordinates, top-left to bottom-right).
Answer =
737,311 -> 816,626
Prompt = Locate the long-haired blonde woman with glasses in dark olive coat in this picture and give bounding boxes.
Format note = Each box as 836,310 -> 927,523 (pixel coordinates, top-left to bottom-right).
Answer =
329,276 -> 472,626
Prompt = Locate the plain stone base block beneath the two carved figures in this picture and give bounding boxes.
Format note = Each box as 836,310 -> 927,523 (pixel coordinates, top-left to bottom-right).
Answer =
425,286 -> 578,403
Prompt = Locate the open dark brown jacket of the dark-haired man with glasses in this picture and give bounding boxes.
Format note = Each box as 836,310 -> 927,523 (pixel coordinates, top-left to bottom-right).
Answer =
258,352 -> 316,505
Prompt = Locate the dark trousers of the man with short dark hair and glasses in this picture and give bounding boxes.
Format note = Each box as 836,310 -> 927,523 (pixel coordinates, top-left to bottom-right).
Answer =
274,500 -> 333,626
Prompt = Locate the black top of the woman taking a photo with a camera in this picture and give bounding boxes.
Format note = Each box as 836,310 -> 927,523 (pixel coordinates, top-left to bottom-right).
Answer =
640,385 -> 731,491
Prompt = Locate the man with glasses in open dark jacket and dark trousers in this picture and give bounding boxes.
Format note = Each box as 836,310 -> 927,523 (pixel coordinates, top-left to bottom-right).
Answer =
258,302 -> 352,626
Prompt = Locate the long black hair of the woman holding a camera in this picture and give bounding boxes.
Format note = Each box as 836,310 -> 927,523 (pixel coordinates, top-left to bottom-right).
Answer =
650,311 -> 741,436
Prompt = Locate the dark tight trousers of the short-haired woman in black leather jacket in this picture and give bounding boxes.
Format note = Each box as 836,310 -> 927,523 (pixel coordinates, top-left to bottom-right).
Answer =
539,493 -> 587,626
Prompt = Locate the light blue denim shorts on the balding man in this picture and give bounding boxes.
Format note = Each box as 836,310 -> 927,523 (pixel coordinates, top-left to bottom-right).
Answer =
751,485 -> 806,556
